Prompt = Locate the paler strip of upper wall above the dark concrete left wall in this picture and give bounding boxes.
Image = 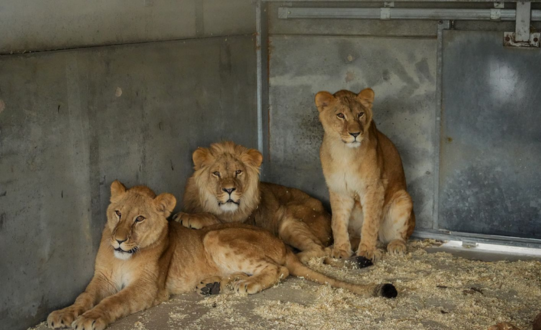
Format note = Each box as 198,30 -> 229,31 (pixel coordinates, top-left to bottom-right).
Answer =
0,0 -> 255,54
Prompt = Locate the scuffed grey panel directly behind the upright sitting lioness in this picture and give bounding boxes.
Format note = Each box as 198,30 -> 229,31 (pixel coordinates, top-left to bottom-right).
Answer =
267,36 -> 436,228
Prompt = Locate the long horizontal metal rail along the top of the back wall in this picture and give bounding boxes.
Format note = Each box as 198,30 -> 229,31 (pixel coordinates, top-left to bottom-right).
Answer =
278,7 -> 541,21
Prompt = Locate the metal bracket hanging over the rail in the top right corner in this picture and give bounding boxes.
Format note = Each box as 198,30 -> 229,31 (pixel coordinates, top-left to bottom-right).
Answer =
503,1 -> 540,48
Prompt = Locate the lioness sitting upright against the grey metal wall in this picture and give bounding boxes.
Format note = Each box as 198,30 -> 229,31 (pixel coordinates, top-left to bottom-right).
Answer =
315,88 -> 415,260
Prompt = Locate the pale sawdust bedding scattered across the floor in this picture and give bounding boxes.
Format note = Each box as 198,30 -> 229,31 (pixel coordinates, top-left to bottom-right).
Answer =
28,240 -> 541,330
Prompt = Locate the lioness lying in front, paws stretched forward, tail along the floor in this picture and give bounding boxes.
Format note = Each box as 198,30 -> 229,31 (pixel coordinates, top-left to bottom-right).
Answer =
47,181 -> 397,330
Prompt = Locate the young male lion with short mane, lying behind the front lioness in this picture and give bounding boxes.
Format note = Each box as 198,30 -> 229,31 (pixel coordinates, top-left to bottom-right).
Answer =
174,142 -> 331,262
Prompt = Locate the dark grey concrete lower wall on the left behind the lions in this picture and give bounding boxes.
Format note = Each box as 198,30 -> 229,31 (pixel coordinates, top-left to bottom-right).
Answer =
0,36 -> 257,329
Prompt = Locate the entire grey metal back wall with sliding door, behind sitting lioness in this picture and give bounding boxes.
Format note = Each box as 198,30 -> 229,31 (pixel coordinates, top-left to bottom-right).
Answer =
257,0 -> 541,247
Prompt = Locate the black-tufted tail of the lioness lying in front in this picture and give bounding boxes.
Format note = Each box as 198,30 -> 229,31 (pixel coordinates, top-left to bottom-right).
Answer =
285,251 -> 397,298
